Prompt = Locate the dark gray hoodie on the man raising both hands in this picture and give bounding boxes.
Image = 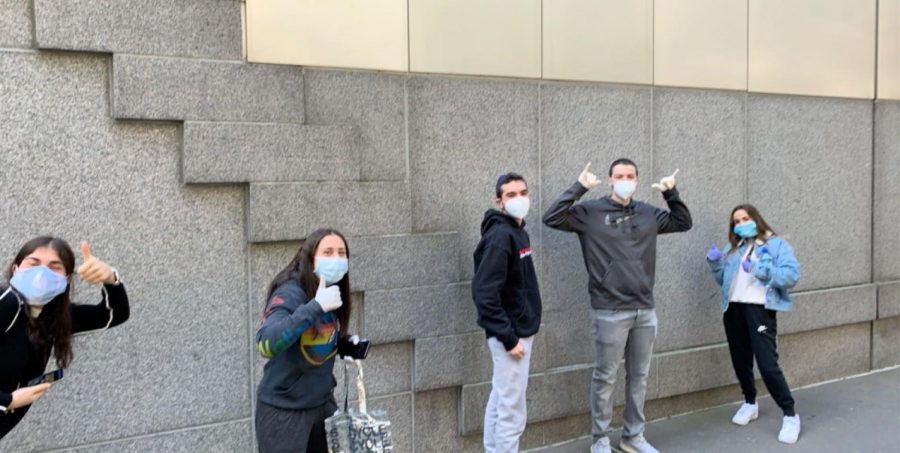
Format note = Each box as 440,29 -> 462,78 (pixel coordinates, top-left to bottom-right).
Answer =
544,182 -> 692,310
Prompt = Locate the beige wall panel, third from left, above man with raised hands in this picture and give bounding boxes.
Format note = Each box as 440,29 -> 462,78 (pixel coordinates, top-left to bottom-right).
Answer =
543,0 -> 653,84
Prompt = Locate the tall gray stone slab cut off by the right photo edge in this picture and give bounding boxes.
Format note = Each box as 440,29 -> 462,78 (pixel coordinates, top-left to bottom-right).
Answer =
872,101 -> 900,281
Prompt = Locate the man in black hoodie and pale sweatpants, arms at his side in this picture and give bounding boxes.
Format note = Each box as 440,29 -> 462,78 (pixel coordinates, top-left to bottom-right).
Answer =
472,173 -> 541,453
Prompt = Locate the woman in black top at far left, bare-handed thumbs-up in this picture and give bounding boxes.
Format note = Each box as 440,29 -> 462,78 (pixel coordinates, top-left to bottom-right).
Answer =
0,236 -> 129,438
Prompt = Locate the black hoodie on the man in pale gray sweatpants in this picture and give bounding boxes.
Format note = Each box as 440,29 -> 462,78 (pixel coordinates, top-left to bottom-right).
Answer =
472,209 -> 541,351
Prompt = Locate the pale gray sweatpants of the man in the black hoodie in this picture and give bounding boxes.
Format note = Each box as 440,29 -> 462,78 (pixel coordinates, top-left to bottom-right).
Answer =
484,336 -> 534,453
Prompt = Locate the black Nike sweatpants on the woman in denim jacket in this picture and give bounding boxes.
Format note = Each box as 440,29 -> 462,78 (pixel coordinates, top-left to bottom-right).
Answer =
722,302 -> 795,417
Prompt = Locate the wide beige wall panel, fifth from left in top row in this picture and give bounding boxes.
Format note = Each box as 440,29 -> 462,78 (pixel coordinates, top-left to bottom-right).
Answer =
748,0 -> 876,99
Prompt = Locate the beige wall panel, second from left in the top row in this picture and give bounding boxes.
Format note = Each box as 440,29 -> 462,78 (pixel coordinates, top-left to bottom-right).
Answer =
409,0 -> 541,78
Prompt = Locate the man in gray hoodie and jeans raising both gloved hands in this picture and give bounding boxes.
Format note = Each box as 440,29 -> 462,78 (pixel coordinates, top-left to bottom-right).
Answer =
544,159 -> 691,453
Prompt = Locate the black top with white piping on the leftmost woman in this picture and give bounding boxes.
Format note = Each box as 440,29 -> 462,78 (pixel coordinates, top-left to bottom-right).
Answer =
0,283 -> 129,438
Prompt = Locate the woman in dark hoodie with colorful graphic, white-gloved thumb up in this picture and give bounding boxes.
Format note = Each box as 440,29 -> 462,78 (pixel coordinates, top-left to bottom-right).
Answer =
255,229 -> 358,453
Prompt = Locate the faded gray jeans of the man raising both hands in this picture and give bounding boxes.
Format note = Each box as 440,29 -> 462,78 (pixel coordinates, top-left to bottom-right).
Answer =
591,309 -> 656,441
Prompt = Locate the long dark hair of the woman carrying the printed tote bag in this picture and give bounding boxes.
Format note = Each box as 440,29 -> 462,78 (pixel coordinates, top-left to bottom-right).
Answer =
267,228 -> 352,337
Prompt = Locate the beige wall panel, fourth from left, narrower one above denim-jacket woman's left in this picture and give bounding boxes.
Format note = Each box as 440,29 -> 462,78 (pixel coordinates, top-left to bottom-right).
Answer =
653,0 -> 747,90
